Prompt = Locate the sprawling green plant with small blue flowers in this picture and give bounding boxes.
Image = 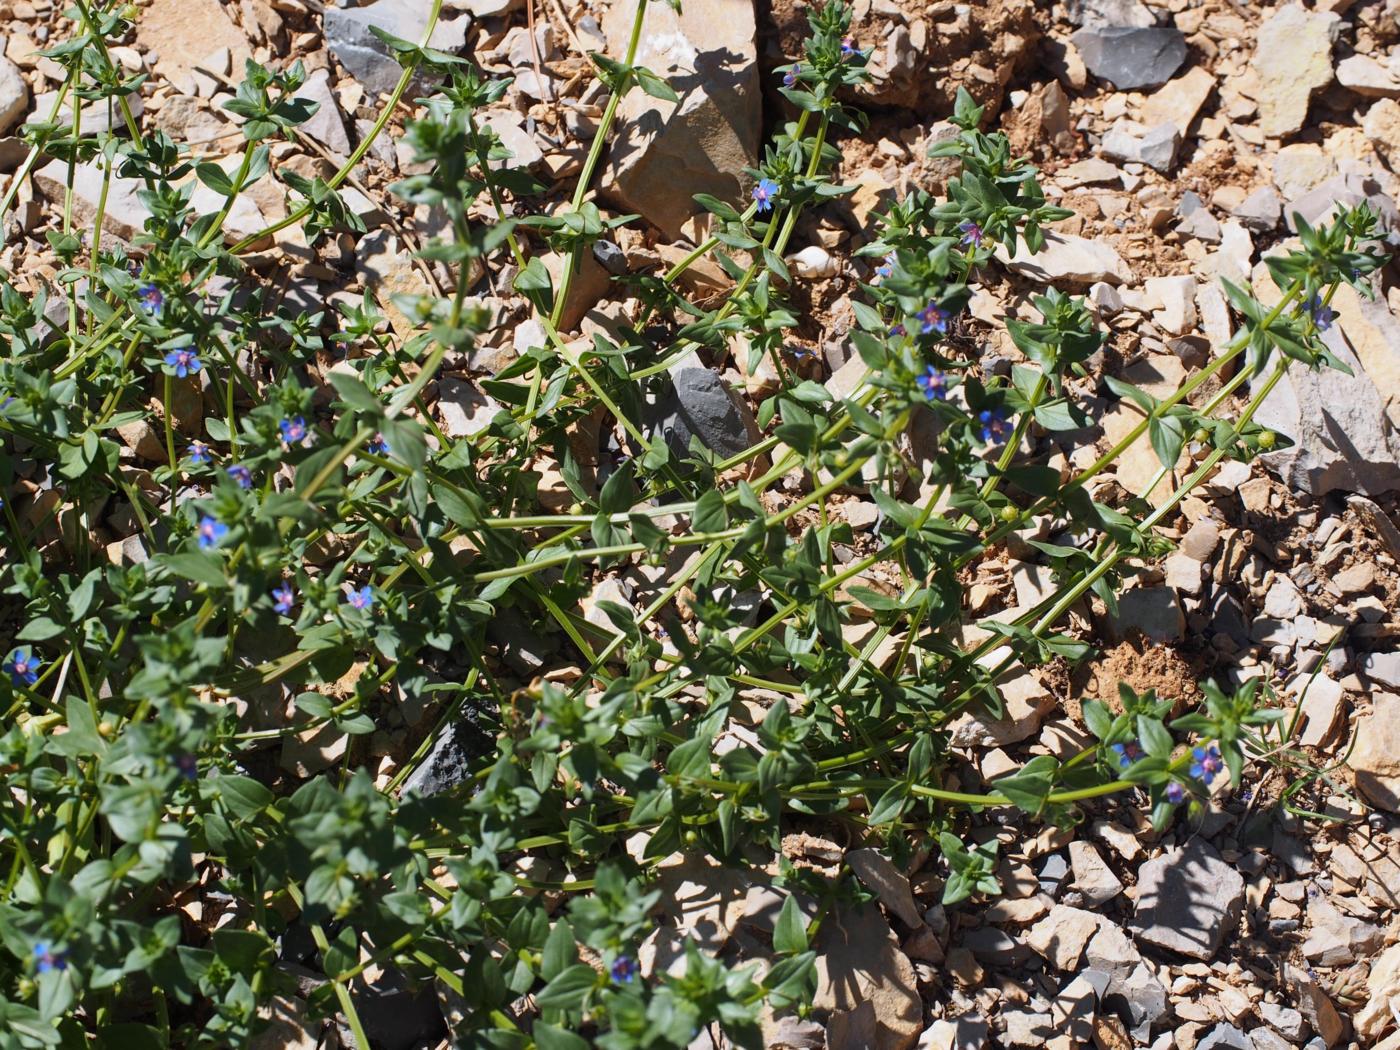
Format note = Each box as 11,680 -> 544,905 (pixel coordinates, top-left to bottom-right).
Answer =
0,0 -> 1382,1050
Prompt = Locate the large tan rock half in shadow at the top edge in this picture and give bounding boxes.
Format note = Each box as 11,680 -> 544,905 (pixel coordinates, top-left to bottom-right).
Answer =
601,0 -> 762,239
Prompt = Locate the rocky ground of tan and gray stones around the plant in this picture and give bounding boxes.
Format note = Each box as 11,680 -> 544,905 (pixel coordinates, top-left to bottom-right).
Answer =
0,0 -> 1400,1050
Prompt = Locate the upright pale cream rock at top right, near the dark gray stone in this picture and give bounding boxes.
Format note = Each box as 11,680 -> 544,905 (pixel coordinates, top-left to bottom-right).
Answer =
1253,4 -> 1341,139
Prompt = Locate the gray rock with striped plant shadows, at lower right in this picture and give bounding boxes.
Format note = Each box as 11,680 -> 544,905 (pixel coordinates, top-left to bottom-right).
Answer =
1133,839 -> 1245,960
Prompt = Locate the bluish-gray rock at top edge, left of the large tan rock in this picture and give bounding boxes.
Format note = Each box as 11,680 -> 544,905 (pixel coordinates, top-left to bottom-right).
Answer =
322,0 -> 469,94
